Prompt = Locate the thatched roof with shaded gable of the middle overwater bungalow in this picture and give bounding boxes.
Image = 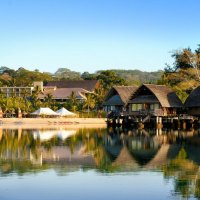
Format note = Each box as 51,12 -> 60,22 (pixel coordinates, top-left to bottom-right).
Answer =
128,84 -> 182,108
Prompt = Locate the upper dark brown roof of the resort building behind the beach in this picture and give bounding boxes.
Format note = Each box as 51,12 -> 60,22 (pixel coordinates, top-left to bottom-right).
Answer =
46,80 -> 99,91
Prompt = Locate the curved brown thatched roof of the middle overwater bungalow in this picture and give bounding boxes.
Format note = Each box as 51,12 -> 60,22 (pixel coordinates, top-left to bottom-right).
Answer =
129,84 -> 182,108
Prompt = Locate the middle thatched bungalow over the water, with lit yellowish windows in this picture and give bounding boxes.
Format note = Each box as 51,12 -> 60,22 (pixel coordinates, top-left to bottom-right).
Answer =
127,84 -> 182,116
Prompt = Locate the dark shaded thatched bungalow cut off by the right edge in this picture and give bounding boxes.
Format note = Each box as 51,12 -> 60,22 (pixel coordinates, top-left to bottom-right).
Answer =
184,86 -> 200,116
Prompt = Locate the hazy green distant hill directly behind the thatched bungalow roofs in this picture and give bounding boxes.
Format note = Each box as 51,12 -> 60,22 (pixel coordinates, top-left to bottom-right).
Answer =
97,69 -> 164,85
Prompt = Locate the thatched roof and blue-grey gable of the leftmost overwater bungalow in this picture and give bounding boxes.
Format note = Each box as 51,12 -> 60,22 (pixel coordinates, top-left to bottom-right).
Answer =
103,86 -> 137,106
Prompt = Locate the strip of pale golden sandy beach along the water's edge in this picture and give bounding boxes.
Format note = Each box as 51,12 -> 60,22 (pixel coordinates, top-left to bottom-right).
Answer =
0,118 -> 107,129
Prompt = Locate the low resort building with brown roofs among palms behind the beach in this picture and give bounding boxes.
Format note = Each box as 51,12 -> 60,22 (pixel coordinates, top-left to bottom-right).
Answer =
0,80 -> 99,103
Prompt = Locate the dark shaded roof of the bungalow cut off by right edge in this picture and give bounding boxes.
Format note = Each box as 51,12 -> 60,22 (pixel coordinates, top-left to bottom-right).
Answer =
185,86 -> 200,107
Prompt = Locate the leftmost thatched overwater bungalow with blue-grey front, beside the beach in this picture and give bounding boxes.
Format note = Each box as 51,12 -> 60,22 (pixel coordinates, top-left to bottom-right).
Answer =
103,86 -> 137,112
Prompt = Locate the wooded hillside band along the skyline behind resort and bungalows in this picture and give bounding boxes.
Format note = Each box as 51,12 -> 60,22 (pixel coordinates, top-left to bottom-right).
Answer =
0,66 -> 163,86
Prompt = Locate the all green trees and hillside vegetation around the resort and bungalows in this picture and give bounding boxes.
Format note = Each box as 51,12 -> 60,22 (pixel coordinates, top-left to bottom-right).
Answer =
0,45 -> 200,111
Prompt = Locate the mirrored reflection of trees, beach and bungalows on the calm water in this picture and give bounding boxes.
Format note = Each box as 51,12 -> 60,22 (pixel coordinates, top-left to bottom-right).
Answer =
0,129 -> 200,198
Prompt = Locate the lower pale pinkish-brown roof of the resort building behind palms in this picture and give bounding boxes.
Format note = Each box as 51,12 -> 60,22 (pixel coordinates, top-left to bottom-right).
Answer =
39,88 -> 89,99
